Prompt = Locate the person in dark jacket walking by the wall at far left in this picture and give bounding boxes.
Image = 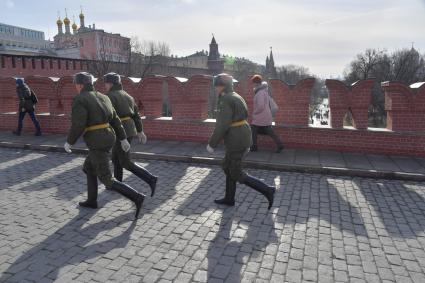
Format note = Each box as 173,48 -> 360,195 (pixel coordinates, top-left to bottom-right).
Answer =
13,78 -> 41,136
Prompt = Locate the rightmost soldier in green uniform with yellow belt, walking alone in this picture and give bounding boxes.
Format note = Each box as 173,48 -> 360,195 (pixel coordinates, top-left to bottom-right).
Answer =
207,74 -> 276,209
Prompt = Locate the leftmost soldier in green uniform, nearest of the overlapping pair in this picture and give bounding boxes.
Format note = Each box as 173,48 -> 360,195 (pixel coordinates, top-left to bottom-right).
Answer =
64,72 -> 145,219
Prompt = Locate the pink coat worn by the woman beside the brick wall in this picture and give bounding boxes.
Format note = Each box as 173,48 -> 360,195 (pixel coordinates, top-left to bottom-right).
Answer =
251,82 -> 273,126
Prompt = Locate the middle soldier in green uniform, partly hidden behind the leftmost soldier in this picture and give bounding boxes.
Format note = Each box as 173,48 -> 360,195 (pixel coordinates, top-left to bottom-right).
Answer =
104,73 -> 158,196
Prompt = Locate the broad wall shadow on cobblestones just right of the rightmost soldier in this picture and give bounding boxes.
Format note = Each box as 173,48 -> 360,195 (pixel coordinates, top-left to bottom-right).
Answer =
276,173 -> 367,239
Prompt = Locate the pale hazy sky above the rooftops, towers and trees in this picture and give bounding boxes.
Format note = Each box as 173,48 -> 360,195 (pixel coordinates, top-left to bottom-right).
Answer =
0,0 -> 425,77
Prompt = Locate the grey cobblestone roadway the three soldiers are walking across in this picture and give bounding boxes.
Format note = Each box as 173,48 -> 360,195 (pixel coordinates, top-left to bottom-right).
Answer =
0,149 -> 425,282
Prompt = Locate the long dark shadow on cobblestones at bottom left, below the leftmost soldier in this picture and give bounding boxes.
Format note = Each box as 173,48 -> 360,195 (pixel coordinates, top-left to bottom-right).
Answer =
0,209 -> 136,282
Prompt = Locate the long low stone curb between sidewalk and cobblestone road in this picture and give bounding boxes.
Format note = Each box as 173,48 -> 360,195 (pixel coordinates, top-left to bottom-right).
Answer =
0,142 -> 425,182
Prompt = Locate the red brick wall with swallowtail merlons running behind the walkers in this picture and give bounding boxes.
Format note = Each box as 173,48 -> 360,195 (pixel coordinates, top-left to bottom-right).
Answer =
0,76 -> 425,157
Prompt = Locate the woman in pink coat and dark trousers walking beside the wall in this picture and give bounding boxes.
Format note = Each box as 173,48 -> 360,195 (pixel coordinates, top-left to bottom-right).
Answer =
251,75 -> 283,153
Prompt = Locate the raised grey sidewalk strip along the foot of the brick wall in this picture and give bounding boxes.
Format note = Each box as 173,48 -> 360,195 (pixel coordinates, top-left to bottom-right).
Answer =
0,132 -> 425,181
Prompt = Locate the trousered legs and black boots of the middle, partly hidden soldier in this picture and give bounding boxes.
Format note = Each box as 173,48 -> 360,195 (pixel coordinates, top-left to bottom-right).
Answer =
112,138 -> 157,195
